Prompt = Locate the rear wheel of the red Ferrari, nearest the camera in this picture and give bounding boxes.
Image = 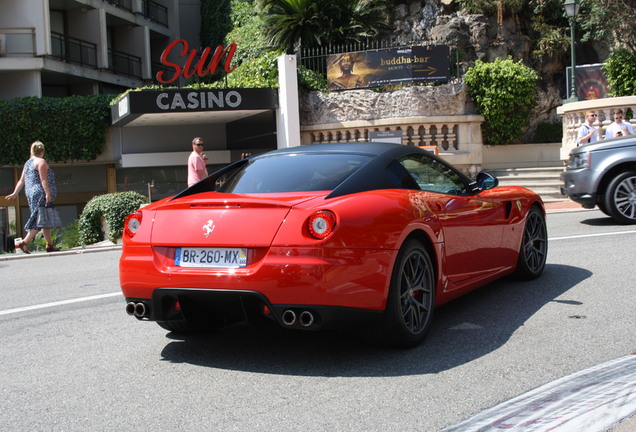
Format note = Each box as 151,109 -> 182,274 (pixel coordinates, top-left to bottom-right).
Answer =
375,240 -> 436,348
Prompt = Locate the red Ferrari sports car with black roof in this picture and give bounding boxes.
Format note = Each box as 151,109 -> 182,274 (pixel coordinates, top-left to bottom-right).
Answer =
120,143 -> 548,347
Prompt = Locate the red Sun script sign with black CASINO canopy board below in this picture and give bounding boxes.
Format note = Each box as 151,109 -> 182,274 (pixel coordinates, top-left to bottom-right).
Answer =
111,40 -> 278,126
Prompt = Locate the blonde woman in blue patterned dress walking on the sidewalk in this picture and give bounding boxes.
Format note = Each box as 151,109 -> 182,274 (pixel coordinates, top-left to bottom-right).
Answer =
6,141 -> 59,254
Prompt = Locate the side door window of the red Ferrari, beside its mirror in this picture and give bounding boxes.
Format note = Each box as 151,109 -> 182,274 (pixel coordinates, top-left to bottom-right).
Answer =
400,155 -> 467,195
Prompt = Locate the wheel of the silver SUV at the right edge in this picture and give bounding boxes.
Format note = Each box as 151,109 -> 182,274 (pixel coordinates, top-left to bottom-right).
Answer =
604,171 -> 636,224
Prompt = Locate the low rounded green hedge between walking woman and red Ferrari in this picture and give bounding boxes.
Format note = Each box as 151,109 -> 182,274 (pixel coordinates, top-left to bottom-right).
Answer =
79,192 -> 148,246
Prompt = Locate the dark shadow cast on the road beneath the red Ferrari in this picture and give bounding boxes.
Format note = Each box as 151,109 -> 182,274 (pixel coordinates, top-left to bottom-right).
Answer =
161,265 -> 591,377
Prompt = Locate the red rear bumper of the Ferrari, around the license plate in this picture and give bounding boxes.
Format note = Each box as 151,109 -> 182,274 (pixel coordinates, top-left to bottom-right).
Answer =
119,245 -> 397,310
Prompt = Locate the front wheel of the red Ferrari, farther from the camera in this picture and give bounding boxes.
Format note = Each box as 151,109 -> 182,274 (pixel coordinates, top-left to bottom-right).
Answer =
515,206 -> 548,280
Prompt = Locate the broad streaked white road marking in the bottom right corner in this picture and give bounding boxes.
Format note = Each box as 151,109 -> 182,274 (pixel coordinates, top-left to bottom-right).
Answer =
443,354 -> 636,432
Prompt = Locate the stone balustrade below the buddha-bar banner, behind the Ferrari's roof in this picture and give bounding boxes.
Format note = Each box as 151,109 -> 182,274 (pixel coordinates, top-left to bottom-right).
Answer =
300,115 -> 484,172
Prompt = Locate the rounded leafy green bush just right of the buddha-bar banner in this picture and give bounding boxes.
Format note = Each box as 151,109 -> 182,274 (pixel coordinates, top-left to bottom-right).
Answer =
464,58 -> 539,145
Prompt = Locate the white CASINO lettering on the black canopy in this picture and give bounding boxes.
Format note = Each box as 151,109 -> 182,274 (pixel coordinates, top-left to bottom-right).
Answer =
156,90 -> 243,111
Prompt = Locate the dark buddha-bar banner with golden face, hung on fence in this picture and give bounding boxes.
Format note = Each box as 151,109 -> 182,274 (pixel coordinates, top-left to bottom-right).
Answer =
327,45 -> 450,90
